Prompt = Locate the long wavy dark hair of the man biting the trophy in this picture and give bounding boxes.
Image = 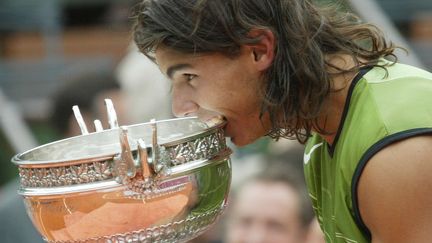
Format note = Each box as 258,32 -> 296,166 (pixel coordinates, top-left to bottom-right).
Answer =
134,0 -> 396,143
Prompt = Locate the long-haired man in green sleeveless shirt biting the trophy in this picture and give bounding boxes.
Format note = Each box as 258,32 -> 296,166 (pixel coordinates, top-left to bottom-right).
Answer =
134,0 -> 432,243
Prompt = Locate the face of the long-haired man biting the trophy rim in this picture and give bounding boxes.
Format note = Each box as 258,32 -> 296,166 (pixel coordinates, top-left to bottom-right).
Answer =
156,47 -> 270,146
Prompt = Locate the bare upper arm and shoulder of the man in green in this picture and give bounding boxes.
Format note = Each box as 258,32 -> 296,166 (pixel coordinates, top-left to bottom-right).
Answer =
358,136 -> 432,243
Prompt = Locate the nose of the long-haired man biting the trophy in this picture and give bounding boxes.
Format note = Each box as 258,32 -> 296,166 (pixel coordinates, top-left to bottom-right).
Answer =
172,88 -> 199,117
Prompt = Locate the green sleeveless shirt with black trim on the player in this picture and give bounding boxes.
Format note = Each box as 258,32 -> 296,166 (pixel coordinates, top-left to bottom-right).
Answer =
304,60 -> 432,243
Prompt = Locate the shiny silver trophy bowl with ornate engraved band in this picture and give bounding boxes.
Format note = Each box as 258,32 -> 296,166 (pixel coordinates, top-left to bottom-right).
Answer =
12,110 -> 231,243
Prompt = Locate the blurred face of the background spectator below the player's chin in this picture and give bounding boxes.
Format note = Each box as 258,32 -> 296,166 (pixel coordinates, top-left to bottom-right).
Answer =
227,182 -> 305,243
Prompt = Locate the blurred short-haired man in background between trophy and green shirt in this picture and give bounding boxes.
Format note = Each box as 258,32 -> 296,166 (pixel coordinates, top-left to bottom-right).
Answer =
226,164 -> 323,243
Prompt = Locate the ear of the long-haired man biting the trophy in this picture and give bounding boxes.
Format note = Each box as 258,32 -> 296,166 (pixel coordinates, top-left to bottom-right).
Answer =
249,29 -> 275,71
